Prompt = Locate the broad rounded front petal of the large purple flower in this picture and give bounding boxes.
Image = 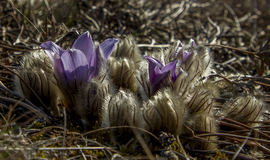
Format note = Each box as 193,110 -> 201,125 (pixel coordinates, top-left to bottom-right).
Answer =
61,49 -> 88,82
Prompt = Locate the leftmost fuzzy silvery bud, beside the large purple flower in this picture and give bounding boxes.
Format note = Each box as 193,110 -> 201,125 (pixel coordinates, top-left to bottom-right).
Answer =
14,50 -> 63,116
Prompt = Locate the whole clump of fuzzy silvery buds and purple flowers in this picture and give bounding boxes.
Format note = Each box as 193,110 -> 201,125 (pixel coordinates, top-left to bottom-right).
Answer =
15,32 -> 265,152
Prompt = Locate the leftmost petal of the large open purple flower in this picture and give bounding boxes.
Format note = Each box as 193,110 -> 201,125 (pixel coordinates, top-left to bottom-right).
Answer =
40,41 -> 64,62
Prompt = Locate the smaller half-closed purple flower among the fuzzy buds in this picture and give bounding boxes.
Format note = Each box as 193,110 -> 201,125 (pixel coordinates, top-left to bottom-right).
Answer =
145,56 -> 181,89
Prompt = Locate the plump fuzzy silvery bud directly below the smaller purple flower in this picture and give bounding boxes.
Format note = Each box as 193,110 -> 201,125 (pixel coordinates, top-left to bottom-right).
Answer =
142,88 -> 188,135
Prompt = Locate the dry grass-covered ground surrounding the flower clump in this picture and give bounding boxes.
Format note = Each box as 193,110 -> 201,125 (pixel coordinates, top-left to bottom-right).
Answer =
0,0 -> 270,159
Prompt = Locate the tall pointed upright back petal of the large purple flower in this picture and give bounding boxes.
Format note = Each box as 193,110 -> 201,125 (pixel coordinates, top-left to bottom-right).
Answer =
72,31 -> 94,62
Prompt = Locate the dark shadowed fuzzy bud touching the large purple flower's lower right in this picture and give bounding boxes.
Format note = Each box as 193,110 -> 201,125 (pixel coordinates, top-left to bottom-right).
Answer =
75,72 -> 116,127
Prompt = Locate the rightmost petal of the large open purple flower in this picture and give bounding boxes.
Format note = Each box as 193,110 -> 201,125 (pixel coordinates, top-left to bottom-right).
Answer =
99,39 -> 119,60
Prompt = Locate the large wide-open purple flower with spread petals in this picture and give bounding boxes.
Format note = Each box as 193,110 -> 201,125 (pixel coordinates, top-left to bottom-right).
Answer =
40,32 -> 119,86
